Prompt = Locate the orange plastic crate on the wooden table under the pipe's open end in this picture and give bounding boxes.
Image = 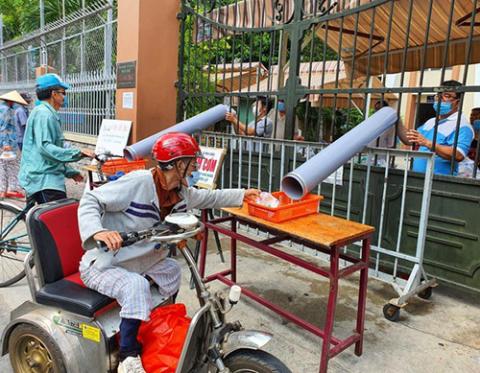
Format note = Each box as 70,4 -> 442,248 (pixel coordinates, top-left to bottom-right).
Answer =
247,192 -> 323,223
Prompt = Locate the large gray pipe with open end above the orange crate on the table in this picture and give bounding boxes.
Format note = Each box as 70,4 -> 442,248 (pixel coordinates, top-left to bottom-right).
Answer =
282,107 -> 397,200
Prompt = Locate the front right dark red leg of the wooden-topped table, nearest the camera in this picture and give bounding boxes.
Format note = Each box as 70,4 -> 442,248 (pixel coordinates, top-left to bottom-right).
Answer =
319,246 -> 339,373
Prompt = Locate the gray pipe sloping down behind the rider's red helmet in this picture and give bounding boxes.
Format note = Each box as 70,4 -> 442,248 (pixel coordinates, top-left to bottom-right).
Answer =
123,105 -> 230,161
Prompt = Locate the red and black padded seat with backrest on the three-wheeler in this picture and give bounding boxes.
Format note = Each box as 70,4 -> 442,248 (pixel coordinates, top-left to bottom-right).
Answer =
27,199 -> 115,317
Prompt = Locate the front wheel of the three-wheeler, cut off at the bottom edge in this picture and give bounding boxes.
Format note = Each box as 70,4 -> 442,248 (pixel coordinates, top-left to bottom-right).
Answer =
224,350 -> 292,373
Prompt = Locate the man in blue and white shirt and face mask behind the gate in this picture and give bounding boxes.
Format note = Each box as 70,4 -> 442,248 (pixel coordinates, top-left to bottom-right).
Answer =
398,80 -> 473,175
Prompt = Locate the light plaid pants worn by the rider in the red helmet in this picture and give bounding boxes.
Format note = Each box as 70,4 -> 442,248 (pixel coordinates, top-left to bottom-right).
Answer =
80,258 -> 181,321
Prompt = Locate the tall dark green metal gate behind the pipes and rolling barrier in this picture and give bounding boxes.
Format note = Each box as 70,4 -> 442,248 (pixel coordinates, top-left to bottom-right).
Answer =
178,0 -> 480,292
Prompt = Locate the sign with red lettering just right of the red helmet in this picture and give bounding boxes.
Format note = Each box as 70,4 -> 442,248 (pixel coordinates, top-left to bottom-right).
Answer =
195,146 -> 227,189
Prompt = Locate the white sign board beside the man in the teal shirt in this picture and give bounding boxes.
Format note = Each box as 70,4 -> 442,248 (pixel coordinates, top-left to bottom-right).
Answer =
95,119 -> 132,155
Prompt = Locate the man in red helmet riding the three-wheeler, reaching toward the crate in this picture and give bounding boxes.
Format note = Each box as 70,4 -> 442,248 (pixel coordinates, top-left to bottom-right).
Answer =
78,132 -> 260,373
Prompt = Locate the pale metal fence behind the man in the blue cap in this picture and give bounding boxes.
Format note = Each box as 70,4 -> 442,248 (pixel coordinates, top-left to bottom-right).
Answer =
0,0 -> 117,135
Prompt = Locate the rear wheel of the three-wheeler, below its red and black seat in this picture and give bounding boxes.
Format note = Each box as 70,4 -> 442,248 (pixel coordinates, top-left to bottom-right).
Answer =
8,324 -> 67,373
